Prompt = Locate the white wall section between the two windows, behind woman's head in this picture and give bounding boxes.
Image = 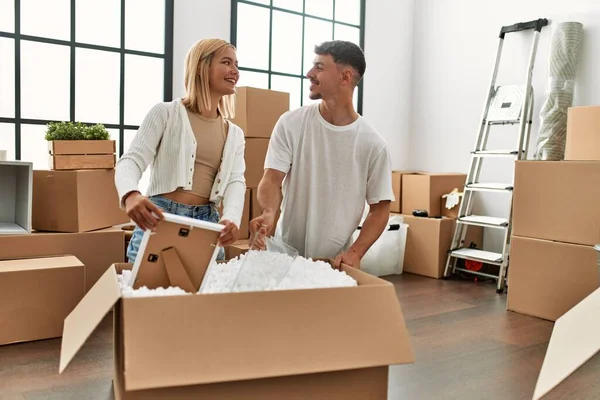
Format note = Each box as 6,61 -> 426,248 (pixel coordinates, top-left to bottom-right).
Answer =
173,0 -> 231,98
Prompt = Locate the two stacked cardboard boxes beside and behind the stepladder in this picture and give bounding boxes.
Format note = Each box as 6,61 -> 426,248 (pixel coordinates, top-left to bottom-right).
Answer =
391,171 -> 483,279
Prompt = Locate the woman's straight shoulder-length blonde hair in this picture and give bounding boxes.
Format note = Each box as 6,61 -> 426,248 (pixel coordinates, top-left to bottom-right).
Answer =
182,39 -> 235,119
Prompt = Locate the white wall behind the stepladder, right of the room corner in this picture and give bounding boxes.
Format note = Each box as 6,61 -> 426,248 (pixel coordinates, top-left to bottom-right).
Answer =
410,0 -> 600,250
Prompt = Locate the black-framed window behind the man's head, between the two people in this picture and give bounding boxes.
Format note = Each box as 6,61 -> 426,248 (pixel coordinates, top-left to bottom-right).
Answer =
231,0 -> 365,113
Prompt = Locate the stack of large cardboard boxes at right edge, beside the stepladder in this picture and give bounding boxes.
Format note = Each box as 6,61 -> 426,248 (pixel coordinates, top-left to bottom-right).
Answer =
507,107 -> 600,321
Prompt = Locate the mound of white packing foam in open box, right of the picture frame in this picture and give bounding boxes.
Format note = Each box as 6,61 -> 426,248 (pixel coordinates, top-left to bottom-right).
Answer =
203,250 -> 358,293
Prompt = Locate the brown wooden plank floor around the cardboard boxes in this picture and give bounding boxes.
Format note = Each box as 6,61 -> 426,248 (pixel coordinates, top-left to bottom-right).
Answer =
0,274 -> 600,400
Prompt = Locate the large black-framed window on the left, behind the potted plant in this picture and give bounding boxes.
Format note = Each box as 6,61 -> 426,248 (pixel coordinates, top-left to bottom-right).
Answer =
0,0 -> 174,169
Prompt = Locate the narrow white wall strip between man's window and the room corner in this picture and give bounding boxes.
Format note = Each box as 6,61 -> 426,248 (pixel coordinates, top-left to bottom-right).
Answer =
363,0 -> 414,170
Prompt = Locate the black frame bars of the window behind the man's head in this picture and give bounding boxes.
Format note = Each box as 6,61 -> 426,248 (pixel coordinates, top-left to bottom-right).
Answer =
230,0 -> 366,115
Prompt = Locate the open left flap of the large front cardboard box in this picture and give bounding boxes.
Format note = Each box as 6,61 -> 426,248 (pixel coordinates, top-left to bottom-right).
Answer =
59,266 -> 121,373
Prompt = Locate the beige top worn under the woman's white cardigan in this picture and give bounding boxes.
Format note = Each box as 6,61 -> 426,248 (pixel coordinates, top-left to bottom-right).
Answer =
177,109 -> 227,199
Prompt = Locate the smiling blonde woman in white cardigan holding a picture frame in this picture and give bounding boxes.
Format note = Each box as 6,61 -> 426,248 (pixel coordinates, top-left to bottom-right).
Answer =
115,39 -> 246,263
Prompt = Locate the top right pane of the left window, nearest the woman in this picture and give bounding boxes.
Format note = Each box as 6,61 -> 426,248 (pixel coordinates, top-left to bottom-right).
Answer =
125,0 -> 165,54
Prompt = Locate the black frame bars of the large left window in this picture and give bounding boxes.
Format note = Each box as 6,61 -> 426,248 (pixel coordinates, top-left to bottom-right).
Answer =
0,0 -> 174,160
